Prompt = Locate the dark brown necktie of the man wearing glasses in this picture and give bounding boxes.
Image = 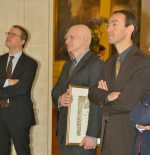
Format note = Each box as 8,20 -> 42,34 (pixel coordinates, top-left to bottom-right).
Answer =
0,56 -> 14,108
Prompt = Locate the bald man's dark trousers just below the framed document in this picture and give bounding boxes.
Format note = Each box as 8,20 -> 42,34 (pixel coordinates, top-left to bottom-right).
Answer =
60,143 -> 96,155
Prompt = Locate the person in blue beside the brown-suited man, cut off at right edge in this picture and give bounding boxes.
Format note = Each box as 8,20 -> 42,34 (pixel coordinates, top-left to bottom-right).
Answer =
130,89 -> 150,155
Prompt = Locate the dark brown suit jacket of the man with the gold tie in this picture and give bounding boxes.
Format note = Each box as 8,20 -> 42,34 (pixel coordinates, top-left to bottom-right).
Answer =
89,46 -> 150,155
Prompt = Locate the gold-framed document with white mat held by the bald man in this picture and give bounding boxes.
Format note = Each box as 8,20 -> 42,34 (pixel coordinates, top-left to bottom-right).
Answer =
66,85 -> 100,145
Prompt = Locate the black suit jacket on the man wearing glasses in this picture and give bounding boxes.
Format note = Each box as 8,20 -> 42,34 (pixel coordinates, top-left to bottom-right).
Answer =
0,53 -> 37,127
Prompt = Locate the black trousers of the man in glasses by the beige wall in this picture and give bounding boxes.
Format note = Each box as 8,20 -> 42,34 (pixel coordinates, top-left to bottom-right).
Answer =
0,108 -> 31,155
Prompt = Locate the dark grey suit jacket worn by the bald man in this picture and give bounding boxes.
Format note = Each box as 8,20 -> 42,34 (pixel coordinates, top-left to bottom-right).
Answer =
52,52 -> 103,142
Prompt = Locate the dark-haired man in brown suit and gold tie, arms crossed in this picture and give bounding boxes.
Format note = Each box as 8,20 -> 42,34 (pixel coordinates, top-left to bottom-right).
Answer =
89,10 -> 150,155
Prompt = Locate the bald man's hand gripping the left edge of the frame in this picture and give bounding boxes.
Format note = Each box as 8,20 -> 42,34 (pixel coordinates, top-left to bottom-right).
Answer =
58,92 -> 72,107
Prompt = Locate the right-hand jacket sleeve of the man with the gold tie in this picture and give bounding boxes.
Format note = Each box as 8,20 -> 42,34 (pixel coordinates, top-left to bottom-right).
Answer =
103,60 -> 150,114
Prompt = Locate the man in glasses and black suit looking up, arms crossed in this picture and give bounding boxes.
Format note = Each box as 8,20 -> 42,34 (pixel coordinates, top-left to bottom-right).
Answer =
0,25 -> 37,155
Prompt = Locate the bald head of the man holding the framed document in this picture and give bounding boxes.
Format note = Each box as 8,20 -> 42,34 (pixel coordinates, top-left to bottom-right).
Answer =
66,24 -> 91,57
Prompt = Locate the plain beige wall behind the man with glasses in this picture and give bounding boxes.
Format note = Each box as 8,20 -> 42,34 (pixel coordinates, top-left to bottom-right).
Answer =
0,0 -> 53,155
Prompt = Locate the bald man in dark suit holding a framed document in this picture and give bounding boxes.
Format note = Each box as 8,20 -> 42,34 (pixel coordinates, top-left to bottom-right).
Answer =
52,25 -> 103,155
